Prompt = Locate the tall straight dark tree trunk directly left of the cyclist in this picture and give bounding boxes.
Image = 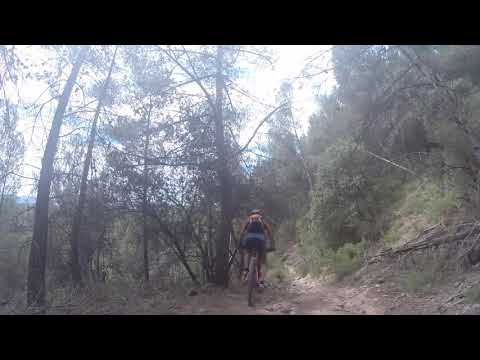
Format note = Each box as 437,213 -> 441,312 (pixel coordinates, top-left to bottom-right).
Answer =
215,46 -> 232,287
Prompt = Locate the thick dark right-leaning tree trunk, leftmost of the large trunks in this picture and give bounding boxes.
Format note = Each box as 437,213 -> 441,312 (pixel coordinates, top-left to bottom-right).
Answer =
27,46 -> 88,306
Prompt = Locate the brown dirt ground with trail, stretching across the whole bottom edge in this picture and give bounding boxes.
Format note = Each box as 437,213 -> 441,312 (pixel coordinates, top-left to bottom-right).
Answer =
0,245 -> 480,315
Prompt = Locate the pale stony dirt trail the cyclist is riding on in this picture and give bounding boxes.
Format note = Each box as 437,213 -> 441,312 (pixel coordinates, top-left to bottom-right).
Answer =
172,246 -> 389,315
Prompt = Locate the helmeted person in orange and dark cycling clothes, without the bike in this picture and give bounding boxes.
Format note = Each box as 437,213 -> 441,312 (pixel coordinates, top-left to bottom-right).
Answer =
240,209 -> 272,287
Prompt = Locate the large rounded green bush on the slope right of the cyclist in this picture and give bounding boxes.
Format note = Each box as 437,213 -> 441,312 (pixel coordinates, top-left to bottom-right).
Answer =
301,140 -> 403,249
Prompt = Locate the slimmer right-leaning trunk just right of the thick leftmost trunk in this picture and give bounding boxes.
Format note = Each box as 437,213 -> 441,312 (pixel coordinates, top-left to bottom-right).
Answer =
71,49 -> 117,285
